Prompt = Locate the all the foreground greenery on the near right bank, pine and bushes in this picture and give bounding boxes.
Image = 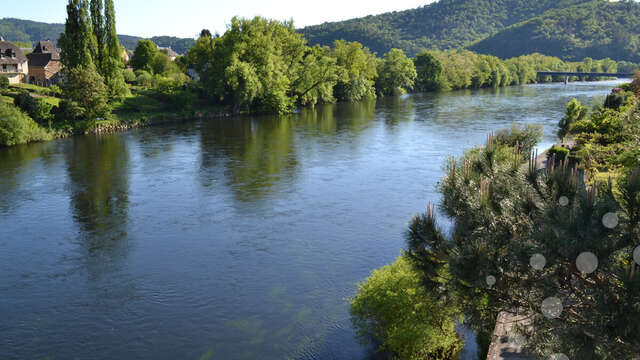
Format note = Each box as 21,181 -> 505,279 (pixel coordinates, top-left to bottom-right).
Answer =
350,76 -> 640,360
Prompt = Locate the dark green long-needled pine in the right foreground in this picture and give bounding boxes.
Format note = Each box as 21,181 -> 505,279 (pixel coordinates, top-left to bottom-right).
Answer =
407,121 -> 640,359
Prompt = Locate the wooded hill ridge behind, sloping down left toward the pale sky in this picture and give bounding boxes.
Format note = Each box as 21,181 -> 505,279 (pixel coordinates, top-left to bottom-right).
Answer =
299,0 -> 591,55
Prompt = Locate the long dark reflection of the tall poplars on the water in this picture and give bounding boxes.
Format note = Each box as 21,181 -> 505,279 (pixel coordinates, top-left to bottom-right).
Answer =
66,136 -> 129,276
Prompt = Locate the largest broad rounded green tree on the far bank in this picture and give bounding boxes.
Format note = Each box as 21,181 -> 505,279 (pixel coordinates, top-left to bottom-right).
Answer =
199,17 -> 308,114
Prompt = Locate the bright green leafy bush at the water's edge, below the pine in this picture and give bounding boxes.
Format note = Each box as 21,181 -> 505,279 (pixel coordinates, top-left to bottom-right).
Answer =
350,256 -> 462,360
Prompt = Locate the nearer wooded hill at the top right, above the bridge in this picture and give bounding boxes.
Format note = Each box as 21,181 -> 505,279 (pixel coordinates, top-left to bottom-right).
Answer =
469,0 -> 640,62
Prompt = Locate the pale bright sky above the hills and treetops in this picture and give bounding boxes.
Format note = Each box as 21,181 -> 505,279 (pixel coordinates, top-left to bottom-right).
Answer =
0,0 -> 434,37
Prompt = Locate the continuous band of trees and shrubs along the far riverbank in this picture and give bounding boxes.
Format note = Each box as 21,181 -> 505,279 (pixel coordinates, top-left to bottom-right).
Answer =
0,4 -> 637,146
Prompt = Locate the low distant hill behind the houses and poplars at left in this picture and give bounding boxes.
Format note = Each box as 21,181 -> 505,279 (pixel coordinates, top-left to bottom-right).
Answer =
0,18 -> 195,54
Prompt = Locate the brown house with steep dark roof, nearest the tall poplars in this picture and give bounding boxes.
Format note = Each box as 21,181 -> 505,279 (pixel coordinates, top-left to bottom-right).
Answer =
27,41 -> 62,86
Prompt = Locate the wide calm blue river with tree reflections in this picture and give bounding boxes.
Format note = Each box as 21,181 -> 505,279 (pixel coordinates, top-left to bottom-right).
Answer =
0,82 -> 616,360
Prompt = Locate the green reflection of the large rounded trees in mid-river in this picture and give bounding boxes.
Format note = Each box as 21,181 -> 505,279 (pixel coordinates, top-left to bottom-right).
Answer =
200,101 -> 376,203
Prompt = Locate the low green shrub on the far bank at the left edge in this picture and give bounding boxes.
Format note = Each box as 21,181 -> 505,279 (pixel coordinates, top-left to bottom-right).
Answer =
0,103 -> 51,146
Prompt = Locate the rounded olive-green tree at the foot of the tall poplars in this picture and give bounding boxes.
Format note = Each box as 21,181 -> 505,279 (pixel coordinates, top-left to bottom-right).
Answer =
63,66 -> 111,121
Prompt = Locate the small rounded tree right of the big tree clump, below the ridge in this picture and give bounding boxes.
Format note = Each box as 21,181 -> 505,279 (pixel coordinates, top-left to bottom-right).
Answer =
376,49 -> 417,95
